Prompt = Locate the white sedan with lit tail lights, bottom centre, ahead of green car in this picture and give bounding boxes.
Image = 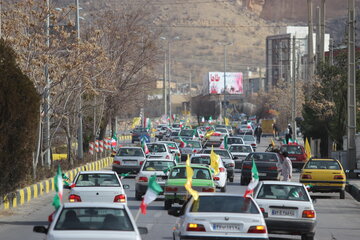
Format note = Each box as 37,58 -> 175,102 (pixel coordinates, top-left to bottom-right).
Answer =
168,193 -> 268,240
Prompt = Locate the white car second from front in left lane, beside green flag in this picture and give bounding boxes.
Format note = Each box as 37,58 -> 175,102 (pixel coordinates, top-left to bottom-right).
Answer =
66,171 -> 129,203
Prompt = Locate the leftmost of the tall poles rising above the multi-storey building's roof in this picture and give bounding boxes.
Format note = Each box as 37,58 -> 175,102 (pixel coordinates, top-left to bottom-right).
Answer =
307,0 -> 314,81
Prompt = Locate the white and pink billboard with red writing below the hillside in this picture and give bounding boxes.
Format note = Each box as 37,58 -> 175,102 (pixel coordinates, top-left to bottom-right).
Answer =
209,72 -> 244,94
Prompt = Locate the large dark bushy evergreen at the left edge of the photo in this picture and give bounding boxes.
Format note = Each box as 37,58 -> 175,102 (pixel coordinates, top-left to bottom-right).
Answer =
0,40 -> 40,197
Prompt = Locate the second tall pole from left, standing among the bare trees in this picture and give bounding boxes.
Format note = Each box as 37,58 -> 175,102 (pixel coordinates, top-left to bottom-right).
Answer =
75,0 -> 84,160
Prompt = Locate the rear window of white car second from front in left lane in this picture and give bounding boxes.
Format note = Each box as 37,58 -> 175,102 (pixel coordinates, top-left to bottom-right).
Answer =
75,173 -> 120,187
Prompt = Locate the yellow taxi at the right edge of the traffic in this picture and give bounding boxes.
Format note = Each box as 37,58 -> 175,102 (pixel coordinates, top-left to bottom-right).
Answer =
300,159 -> 346,199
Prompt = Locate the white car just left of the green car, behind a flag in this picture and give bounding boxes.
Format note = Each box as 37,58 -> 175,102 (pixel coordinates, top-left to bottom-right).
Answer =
135,159 -> 176,200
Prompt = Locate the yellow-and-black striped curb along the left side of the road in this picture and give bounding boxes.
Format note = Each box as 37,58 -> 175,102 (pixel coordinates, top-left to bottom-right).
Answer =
0,157 -> 112,210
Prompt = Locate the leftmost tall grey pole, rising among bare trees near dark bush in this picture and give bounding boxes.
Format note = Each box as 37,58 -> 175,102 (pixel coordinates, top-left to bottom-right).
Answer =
43,0 -> 51,168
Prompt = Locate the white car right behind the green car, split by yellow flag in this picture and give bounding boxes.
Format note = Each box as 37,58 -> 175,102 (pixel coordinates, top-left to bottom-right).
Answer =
190,154 -> 227,192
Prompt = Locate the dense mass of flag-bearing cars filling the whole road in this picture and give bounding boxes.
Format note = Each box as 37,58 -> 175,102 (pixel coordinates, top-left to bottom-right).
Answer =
33,121 -> 346,240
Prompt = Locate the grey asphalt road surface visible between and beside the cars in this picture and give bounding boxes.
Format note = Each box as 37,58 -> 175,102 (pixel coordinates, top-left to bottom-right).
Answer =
0,138 -> 360,240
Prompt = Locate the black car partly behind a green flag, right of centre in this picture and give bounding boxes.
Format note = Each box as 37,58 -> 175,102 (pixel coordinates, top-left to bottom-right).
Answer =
240,152 -> 281,185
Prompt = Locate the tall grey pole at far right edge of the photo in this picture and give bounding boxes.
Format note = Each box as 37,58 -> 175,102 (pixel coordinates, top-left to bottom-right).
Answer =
347,0 -> 356,170
